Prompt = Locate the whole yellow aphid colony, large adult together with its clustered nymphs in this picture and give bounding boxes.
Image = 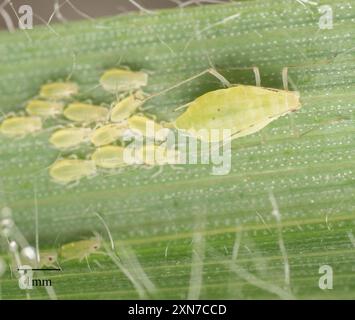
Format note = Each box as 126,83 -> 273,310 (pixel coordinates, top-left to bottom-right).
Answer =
0,67 -> 301,184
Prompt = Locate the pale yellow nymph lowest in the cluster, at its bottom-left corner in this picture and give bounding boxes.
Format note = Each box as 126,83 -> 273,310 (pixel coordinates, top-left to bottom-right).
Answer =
49,159 -> 96,184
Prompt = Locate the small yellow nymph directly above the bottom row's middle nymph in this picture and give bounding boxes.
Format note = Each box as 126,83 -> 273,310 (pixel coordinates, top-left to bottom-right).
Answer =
90,123 -> 127,147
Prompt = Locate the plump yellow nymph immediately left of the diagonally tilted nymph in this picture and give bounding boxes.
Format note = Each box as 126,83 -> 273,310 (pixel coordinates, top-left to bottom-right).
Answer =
64,102 -> 109,123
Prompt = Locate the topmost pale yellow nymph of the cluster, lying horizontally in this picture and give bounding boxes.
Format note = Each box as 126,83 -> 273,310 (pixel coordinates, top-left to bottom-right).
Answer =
100,69 -> 148,93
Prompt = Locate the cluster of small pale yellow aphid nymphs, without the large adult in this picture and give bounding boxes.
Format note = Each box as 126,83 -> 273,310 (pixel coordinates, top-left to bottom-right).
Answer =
0,68 -> 182,184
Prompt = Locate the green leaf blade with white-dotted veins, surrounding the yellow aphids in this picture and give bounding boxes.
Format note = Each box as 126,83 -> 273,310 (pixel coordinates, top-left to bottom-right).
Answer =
0,0 -> 355,299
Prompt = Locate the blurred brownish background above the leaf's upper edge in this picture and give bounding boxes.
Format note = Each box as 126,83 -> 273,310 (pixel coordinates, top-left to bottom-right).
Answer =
0,0 -> 228,29
